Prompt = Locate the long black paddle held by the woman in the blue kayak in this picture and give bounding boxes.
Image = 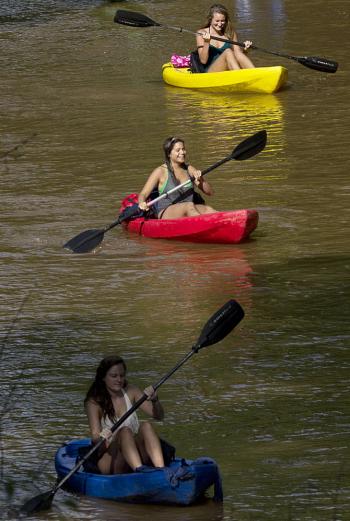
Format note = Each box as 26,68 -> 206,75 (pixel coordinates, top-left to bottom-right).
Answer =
19,300 -> 244,516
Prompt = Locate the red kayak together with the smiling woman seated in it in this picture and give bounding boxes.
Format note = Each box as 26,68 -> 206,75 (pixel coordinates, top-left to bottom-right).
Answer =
120,133 -> 259,244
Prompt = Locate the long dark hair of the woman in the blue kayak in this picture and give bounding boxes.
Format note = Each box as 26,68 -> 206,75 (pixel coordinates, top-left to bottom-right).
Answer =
84,356 -> 127,421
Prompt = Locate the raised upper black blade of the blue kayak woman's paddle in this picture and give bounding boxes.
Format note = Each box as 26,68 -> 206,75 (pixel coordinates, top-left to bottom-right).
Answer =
192,300 -> 244,352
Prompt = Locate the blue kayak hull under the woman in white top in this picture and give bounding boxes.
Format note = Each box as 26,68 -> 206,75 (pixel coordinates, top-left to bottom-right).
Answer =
55,438 -> 222,505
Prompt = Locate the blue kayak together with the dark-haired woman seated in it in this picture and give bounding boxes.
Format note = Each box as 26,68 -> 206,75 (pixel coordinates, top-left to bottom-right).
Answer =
55,356 -> 222,505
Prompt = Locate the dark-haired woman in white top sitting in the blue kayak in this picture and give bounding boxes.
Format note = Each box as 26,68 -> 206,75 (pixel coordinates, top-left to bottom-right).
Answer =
84,356 -> 164,474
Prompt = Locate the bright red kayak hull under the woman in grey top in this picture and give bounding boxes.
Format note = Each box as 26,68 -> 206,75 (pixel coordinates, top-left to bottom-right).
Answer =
120,194 -> 259,244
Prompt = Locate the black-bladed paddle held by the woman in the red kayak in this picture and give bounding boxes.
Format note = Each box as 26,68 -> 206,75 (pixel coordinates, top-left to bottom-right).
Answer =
63,130 -> 267,253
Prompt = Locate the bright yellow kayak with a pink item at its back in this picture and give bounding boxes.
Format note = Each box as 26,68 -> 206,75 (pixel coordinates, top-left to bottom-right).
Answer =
163,63 -> 288,94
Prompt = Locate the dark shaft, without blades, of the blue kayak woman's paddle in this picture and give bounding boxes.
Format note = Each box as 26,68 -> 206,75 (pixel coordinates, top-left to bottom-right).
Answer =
51,346 -> 198,496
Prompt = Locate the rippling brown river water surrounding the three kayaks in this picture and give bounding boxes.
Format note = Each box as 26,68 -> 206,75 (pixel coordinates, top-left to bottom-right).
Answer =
0,0 -> 350,521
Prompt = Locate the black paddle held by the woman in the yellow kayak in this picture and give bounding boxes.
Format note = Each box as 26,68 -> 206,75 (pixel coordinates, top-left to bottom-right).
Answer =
114,9 -> 338,72
